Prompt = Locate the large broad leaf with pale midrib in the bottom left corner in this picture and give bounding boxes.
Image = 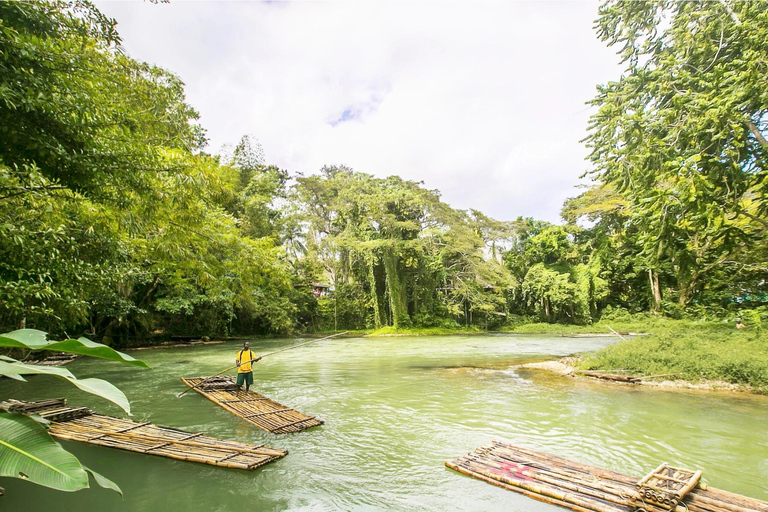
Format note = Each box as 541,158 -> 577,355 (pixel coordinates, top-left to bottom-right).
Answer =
0,413 -> 88,491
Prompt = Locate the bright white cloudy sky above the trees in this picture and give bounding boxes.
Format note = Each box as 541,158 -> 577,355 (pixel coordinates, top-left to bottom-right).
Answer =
97,0 -> 620,222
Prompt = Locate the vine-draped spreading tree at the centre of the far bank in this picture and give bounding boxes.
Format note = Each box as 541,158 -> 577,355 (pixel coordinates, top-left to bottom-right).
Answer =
296,167 -> 510,328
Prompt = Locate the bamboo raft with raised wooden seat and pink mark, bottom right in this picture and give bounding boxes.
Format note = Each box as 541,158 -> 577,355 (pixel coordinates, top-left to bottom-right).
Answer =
445,441 -> 768,512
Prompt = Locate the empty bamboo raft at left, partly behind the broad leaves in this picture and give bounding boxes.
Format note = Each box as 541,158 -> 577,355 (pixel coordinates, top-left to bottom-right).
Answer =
0,398 -> 288,470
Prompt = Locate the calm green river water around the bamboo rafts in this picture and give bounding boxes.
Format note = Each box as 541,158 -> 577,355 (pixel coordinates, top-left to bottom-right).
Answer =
0,335 -> 768,512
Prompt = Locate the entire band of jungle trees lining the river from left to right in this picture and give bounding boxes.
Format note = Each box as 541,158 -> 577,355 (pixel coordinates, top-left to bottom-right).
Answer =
0,0 -> 768,346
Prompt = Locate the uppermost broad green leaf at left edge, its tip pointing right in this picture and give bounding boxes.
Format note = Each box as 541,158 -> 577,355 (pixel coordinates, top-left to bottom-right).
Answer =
0,329 -> 149,368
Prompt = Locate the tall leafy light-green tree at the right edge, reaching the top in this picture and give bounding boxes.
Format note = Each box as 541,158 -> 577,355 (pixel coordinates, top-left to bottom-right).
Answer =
586,0 -> 768,306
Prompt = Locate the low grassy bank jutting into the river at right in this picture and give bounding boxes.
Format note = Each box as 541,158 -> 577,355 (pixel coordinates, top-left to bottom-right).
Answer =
580,319 -> 768,393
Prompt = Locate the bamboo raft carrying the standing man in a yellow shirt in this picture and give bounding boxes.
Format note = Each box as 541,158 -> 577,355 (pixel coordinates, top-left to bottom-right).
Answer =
181,375 -> 323,434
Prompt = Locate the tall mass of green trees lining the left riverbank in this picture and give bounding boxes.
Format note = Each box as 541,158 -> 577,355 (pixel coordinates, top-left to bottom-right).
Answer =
0,2 -> 294,343
